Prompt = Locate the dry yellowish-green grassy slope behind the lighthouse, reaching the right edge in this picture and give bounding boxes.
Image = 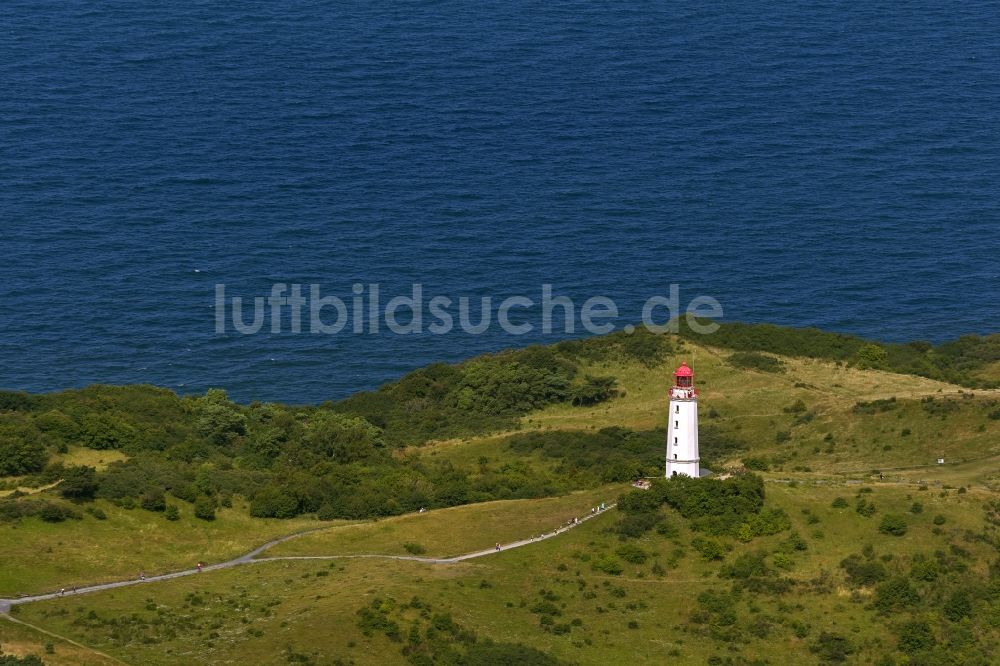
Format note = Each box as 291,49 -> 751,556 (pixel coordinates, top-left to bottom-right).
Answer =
414,342 -> 1000,478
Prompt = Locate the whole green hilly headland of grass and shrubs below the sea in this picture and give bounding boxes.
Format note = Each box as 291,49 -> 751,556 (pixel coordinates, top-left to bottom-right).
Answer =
0,325 -> 1000,664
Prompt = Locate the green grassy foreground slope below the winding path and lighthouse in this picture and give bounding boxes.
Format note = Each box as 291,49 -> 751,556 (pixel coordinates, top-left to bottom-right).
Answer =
7,485 -> 1000,664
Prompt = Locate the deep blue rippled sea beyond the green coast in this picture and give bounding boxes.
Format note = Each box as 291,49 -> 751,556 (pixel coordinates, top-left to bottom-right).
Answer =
0,0 -> 1000,402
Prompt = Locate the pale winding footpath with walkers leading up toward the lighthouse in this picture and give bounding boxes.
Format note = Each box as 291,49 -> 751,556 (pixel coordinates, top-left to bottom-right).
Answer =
0,504 -> 615,615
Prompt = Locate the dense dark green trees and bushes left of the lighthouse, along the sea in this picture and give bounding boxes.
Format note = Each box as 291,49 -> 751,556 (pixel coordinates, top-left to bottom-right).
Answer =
0,339 -> 648,520
